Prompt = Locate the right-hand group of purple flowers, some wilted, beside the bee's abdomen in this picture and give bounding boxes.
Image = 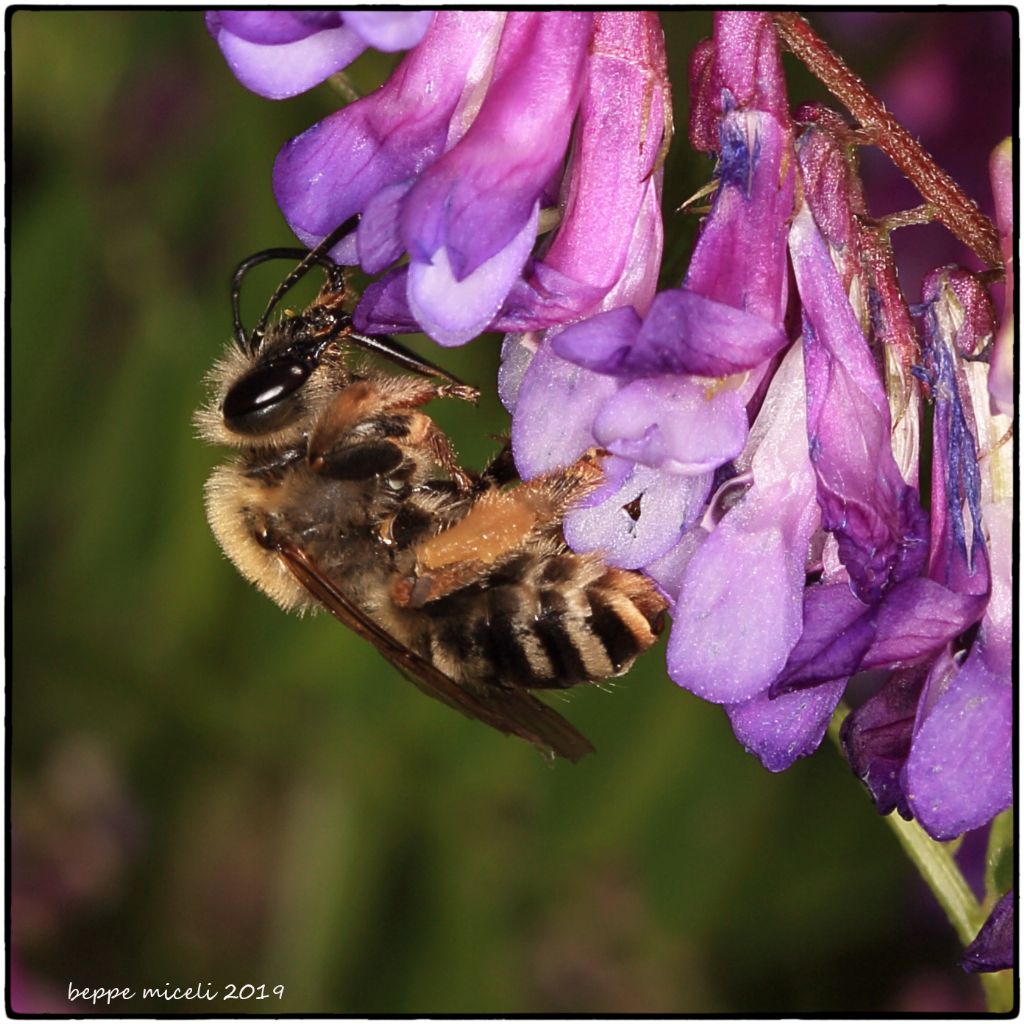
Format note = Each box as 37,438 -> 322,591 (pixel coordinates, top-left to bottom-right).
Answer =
513,12 -> 1012,839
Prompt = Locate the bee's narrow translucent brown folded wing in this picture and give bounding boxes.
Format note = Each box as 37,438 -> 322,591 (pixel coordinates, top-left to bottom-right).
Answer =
274,542 -> 594,761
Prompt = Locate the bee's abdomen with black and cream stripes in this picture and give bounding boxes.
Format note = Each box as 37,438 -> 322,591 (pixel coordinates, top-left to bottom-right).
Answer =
424,554 -> 665,688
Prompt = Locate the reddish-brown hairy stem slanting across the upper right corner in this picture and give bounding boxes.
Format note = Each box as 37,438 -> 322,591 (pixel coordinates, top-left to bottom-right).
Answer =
773,11 -> 1002,269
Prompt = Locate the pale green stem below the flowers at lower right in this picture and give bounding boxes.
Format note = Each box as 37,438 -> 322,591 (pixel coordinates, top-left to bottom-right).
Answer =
828,702 -> 1013,1013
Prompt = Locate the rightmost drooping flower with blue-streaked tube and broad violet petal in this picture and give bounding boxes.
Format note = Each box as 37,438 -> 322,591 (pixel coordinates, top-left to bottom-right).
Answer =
843,270 -> 1013,839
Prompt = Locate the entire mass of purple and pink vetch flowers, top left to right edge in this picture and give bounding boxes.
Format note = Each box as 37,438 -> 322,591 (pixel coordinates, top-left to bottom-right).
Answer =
209,10 -> 1014,970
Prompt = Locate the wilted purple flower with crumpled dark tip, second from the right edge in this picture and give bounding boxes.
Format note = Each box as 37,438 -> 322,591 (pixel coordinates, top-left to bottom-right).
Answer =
771,149 -> 988,753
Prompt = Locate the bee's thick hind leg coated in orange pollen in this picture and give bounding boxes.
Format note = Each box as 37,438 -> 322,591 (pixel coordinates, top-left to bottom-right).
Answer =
392,450 -> 603,607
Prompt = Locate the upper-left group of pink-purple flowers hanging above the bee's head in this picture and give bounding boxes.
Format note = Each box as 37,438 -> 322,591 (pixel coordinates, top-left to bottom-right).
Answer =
208,10 -> 669,345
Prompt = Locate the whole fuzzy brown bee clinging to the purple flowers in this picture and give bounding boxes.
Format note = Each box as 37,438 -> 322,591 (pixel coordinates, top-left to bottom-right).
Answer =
196,221 -> 666,761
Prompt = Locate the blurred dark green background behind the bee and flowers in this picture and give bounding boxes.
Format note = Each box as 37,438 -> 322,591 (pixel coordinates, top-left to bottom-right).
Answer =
8,10 -> 1011,1015
